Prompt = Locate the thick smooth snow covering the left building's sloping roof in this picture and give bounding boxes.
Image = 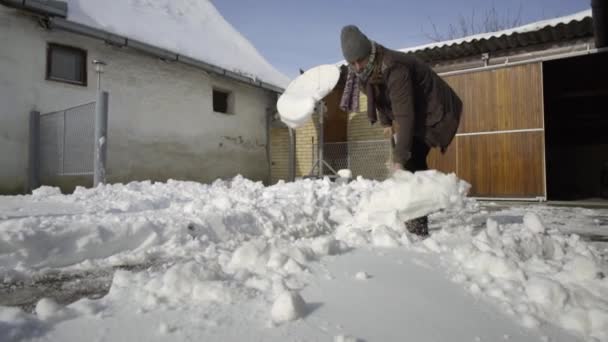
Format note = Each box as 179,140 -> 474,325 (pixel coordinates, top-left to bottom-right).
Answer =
66,0 -> 289,88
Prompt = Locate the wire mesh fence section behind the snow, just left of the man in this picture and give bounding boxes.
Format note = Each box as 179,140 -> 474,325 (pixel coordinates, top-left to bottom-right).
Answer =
312,140 -> 392,180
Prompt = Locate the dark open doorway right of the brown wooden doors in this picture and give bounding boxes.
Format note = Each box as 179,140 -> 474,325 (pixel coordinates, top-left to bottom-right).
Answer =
543,53 -> 608,200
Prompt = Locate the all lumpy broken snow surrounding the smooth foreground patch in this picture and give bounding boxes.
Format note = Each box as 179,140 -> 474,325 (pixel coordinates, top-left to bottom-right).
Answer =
0,171 -> 608,340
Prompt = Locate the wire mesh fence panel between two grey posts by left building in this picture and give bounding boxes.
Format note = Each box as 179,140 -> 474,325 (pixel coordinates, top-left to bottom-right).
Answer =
40,102 -> 95,177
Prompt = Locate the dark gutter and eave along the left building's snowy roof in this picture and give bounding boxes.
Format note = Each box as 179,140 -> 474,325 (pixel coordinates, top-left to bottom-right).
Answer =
0,0 -> 285,93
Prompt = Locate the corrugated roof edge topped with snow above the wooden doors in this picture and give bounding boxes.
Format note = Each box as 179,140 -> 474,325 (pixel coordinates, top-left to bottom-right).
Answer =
399,9 -> 593,61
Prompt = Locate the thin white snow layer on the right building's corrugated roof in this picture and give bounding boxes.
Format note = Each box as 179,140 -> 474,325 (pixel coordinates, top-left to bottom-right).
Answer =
399,9 -> 591,52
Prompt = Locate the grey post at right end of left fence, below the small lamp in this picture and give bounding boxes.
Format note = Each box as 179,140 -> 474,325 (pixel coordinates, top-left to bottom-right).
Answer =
93,91 -> 109,186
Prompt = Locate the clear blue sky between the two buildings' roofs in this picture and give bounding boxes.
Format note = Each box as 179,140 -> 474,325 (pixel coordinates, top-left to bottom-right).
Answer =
213,0 -> 591,77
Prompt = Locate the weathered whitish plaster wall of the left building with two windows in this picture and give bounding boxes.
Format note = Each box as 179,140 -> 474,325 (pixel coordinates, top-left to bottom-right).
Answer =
0,6 -> 274,193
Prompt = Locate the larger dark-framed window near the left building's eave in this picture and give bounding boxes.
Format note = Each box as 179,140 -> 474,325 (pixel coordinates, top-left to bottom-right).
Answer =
46,44 -> 87,86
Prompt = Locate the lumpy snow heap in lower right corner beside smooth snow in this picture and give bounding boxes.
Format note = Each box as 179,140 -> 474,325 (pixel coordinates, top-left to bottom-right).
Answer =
432,212 -> 608,341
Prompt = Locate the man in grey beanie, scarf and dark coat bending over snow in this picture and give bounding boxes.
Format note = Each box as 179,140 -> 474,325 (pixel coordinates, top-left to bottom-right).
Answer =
340,25 -> 462,236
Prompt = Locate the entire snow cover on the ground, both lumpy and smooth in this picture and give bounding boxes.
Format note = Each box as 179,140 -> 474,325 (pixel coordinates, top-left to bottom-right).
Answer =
0,171 -> 608,341
